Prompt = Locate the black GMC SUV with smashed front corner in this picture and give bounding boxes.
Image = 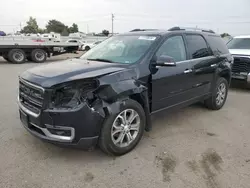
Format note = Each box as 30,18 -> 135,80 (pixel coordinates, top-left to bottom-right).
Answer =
19,27 -> 233,155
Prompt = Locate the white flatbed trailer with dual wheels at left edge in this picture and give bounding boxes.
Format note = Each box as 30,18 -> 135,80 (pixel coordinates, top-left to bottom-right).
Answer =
0,40 -> 79,64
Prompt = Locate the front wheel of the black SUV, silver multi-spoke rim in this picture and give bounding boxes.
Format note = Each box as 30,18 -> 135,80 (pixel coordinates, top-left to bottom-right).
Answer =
99,99 -> 146,156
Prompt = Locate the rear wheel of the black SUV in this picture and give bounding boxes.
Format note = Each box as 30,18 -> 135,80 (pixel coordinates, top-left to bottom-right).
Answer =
205,77 -> 229,110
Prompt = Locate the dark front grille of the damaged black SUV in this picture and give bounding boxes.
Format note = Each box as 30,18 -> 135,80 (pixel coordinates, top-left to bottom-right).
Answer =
19,80 -> 44,114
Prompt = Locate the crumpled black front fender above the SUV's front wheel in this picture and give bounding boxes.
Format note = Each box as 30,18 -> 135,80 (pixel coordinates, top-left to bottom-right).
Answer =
90,71 -> 152,131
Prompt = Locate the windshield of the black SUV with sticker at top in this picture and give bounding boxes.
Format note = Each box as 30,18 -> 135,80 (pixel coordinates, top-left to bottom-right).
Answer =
81,36 -> 157,64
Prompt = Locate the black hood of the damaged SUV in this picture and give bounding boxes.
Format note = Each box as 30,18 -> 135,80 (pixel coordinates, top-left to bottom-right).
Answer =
20,59 -> 125,88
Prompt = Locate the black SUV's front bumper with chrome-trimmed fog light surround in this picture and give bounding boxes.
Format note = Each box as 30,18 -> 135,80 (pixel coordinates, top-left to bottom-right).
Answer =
18,100 -> 104,149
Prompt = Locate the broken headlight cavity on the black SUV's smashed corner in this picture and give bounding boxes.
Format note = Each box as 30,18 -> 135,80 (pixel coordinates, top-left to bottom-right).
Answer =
49,81 -> 97,109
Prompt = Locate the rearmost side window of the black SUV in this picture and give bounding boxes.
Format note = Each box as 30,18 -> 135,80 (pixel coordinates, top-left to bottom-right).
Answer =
208,36 -> 229,55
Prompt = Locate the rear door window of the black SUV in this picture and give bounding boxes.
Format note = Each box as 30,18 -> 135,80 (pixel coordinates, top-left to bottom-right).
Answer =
187,35 -> 210,59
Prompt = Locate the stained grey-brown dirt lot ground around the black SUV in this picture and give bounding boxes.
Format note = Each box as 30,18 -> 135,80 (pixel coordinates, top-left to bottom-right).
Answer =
0,55 -> 250,188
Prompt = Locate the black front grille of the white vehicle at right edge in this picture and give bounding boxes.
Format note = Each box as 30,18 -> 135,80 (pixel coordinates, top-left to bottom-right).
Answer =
232,57 -> 250,73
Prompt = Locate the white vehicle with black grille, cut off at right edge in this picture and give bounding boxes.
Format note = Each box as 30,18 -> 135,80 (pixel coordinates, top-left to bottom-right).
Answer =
227,35 -> 250,85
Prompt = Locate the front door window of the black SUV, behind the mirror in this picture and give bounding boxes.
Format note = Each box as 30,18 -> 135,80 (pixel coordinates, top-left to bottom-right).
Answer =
156,36 -> 186,61
